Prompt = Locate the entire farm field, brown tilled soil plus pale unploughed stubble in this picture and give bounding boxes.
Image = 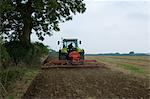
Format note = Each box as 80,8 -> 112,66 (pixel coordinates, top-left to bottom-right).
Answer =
23,56 -> 150,99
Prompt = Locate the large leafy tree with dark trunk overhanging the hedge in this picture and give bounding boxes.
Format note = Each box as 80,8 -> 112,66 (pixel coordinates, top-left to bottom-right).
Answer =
0,0 -> 86,44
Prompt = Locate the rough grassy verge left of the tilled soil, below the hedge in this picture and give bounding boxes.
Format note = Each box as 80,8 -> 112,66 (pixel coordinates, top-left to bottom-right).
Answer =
0,66 -> 39,99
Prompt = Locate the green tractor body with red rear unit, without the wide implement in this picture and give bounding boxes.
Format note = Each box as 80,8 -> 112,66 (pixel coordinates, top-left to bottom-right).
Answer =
58,39 -> 84,61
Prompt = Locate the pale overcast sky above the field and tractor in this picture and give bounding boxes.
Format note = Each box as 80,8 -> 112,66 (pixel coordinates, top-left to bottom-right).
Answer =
31,0 -> 150,54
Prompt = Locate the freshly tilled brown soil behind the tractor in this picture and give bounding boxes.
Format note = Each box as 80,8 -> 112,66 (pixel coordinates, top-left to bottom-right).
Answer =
23,64 -> 150,99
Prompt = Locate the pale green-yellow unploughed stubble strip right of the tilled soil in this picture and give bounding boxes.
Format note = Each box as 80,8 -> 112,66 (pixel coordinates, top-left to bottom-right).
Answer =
87,56 -> 150,77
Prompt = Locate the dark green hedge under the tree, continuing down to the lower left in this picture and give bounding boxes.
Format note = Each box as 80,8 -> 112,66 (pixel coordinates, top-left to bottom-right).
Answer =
0,41 -> 49,98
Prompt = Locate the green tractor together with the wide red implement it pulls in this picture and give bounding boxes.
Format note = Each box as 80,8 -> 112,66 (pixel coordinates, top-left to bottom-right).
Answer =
42,39 -> 99,69
